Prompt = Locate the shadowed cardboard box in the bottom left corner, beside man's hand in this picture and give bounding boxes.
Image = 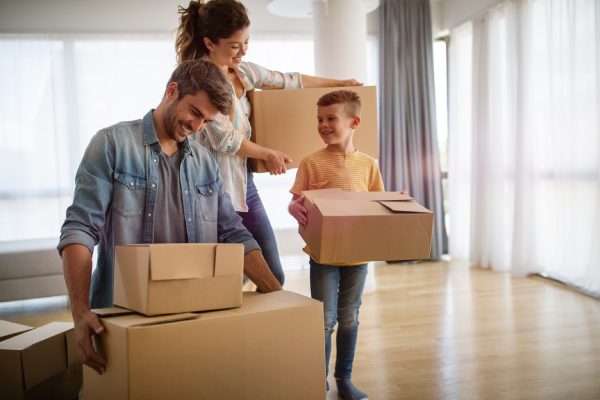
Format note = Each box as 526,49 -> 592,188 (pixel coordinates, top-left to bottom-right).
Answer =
0,322 -> 83,399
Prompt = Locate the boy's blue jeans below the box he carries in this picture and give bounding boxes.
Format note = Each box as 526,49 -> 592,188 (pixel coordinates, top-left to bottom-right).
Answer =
310,259 -> 367,378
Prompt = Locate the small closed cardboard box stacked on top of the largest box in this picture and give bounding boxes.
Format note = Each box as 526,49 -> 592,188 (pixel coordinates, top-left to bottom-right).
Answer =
113,243 -> 244,315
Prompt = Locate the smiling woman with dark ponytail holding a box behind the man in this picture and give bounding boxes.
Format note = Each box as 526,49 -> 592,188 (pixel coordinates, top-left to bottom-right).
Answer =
175,0 -> 360,285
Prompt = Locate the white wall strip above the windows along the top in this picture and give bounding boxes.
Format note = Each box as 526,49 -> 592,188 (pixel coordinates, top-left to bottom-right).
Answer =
0,0 -> 378,34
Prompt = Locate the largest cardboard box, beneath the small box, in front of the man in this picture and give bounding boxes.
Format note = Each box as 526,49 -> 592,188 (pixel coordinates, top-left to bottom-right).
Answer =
83,291 -> 326,400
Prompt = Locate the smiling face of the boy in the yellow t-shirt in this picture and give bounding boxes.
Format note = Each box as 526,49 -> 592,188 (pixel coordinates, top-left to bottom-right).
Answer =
317,104 -> 360,150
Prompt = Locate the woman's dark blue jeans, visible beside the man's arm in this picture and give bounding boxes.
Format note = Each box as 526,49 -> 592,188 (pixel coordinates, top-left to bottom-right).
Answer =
238,170 -> 285,286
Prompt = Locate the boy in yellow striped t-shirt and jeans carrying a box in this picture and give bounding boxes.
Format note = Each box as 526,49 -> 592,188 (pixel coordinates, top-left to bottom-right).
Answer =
288,90 -> 384,400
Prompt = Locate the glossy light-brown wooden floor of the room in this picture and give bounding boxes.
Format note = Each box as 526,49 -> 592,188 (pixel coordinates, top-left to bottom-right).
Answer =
0,261 -> 600,400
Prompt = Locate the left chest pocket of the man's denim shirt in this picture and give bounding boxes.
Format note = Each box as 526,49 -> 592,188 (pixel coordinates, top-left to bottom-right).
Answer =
112,170 -> 146,220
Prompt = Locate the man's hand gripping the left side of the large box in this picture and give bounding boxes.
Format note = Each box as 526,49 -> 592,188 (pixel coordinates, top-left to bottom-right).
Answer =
73,309 -> 106,374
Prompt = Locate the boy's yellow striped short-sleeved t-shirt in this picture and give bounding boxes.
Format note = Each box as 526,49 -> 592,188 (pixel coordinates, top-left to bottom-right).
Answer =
290,148 -> 384,266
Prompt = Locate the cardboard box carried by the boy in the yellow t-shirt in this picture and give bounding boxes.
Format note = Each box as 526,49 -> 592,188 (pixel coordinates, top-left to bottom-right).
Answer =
298,189 -> 433,264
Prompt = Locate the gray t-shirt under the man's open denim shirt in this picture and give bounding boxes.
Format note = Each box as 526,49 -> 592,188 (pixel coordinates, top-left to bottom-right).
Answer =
154,146 -> 187,243
